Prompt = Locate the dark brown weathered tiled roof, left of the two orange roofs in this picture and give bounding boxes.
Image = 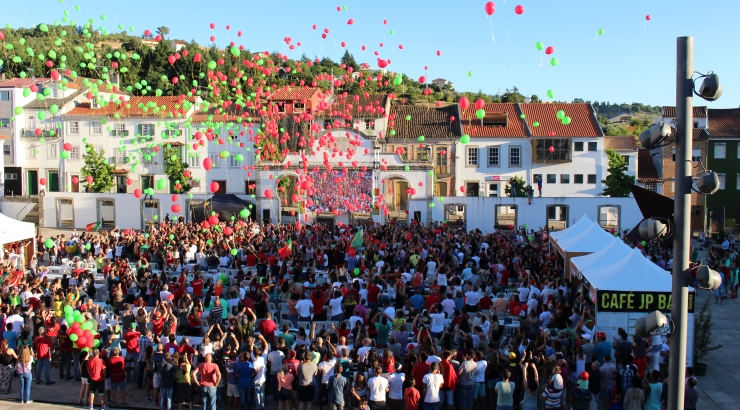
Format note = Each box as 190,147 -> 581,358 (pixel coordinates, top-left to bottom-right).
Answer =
388,104 -> 462,139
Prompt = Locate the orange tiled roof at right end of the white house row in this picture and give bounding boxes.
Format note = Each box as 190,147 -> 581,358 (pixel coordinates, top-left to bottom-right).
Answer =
519,103 -> 604,137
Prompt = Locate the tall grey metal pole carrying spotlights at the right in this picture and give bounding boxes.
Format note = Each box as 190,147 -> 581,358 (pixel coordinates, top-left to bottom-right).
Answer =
668,37 -> 694,410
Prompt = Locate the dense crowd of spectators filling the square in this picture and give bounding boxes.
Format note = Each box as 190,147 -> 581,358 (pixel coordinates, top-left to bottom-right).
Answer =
0,215 -> 716,410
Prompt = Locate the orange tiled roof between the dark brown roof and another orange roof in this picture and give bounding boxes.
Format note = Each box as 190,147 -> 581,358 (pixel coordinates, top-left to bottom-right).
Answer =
460,103 -> 529,138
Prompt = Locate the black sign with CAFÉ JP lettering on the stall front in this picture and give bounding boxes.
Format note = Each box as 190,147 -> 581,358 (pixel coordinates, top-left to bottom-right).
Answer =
596,290 -> 694,313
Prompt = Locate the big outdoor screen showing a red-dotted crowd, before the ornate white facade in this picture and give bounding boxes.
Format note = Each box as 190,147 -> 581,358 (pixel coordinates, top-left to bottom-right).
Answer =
310,171 -> 373,212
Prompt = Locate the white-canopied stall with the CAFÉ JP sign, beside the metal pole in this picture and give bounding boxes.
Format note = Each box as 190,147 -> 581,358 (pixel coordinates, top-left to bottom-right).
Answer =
573,247 -> 695,364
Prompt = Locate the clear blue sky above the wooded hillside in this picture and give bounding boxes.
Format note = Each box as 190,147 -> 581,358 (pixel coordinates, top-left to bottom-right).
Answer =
5,0 -> 740,108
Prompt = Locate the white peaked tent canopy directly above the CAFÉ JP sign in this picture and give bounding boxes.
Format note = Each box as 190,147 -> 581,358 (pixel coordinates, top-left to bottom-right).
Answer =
583,248 -> 672,292
